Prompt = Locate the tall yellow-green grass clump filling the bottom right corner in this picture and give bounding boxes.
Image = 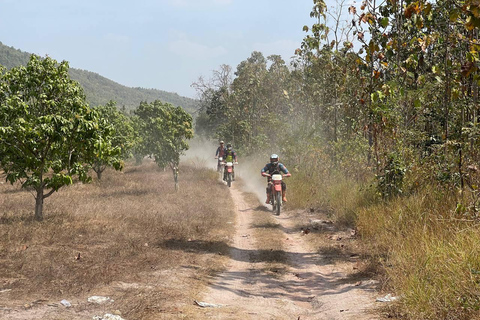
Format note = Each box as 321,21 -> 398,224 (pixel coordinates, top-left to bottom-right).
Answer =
357,189 -> 480,319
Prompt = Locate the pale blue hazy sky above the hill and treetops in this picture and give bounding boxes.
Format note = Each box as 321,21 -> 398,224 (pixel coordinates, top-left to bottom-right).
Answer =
0,0 -> 344,98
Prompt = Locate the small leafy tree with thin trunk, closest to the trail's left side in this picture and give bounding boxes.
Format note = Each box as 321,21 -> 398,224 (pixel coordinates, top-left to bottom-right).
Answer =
135,100 -> 193,190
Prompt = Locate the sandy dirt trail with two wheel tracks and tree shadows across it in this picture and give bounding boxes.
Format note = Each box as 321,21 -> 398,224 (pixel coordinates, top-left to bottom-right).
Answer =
194,186 -> 377,320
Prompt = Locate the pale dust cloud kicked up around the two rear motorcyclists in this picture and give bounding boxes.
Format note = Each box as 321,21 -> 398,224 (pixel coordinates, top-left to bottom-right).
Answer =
181,139 -> 269,204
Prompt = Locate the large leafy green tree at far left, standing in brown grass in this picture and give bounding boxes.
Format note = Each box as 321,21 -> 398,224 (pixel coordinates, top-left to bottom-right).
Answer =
0,55 -> 111,220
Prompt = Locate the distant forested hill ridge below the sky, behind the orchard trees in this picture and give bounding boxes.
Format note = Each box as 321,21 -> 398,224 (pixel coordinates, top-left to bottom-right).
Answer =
0,42 -> 198,114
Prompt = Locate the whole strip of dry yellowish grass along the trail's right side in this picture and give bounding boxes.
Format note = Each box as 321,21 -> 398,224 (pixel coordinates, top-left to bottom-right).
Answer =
289,164 -> 480,320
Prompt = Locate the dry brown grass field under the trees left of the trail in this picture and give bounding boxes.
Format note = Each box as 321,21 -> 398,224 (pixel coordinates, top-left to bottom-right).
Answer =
0,162 -> 234,319
